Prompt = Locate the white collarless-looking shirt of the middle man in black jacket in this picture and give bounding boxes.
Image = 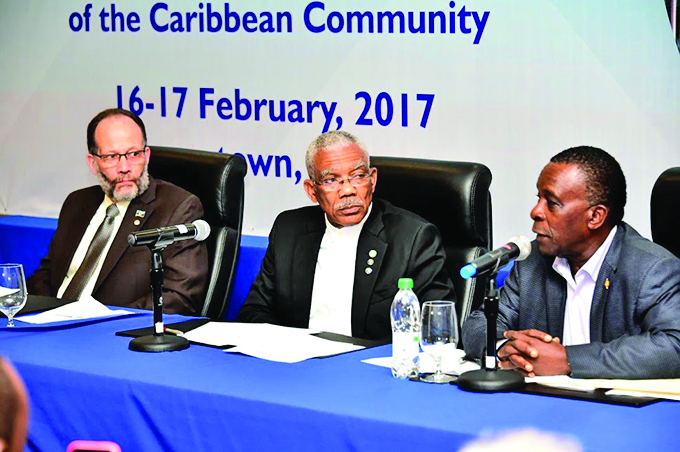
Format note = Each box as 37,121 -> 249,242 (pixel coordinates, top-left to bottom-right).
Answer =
309,203 -> 373,336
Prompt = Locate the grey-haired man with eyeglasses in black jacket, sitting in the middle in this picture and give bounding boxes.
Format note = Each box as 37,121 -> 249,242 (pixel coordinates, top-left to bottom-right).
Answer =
237,131 -> 455,340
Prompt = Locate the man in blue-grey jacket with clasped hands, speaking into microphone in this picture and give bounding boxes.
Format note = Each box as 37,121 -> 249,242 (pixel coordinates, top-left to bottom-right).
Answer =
463,146 -> 680,378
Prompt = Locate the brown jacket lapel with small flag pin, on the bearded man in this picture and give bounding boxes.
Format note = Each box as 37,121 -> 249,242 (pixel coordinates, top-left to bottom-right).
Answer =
92,179 -> 156,293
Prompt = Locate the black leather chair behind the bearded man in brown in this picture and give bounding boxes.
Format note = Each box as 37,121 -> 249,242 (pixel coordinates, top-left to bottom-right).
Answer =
149,146 -> 246,320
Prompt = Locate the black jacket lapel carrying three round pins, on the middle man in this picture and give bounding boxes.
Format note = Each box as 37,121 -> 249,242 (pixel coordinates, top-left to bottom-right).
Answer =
352,202 -> 389,337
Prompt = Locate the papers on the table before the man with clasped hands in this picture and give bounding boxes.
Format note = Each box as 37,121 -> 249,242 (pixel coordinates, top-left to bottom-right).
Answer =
525,375 -> 680,400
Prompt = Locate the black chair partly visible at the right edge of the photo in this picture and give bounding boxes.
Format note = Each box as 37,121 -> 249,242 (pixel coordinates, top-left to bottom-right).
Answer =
651,166 -> 680,257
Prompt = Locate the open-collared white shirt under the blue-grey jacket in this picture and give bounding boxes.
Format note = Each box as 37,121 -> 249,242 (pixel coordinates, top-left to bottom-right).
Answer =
553,226 -> 617,345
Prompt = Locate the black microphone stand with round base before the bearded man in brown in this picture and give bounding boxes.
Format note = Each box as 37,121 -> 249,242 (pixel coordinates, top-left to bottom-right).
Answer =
129,232 -> 189,352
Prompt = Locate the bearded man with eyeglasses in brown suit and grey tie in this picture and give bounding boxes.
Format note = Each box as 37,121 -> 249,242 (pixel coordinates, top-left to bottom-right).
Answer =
28,109 -> 208,314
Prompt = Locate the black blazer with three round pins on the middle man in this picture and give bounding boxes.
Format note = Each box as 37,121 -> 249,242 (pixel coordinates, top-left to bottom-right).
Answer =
237,199 -> 455,339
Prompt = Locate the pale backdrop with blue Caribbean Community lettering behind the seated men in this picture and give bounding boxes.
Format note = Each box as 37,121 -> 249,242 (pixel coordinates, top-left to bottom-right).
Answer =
0,0 -> 680,243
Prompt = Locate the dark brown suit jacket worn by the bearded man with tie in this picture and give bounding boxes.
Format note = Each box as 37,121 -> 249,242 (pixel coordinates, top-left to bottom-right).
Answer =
28,179 -> 208,314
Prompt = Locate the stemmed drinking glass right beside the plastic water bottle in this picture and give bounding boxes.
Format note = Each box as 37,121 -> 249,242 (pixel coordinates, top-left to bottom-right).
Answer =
420,301 -> 458,383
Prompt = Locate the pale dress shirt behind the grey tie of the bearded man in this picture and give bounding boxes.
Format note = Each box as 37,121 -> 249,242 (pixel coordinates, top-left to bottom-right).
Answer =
57,196 -> 130,298
